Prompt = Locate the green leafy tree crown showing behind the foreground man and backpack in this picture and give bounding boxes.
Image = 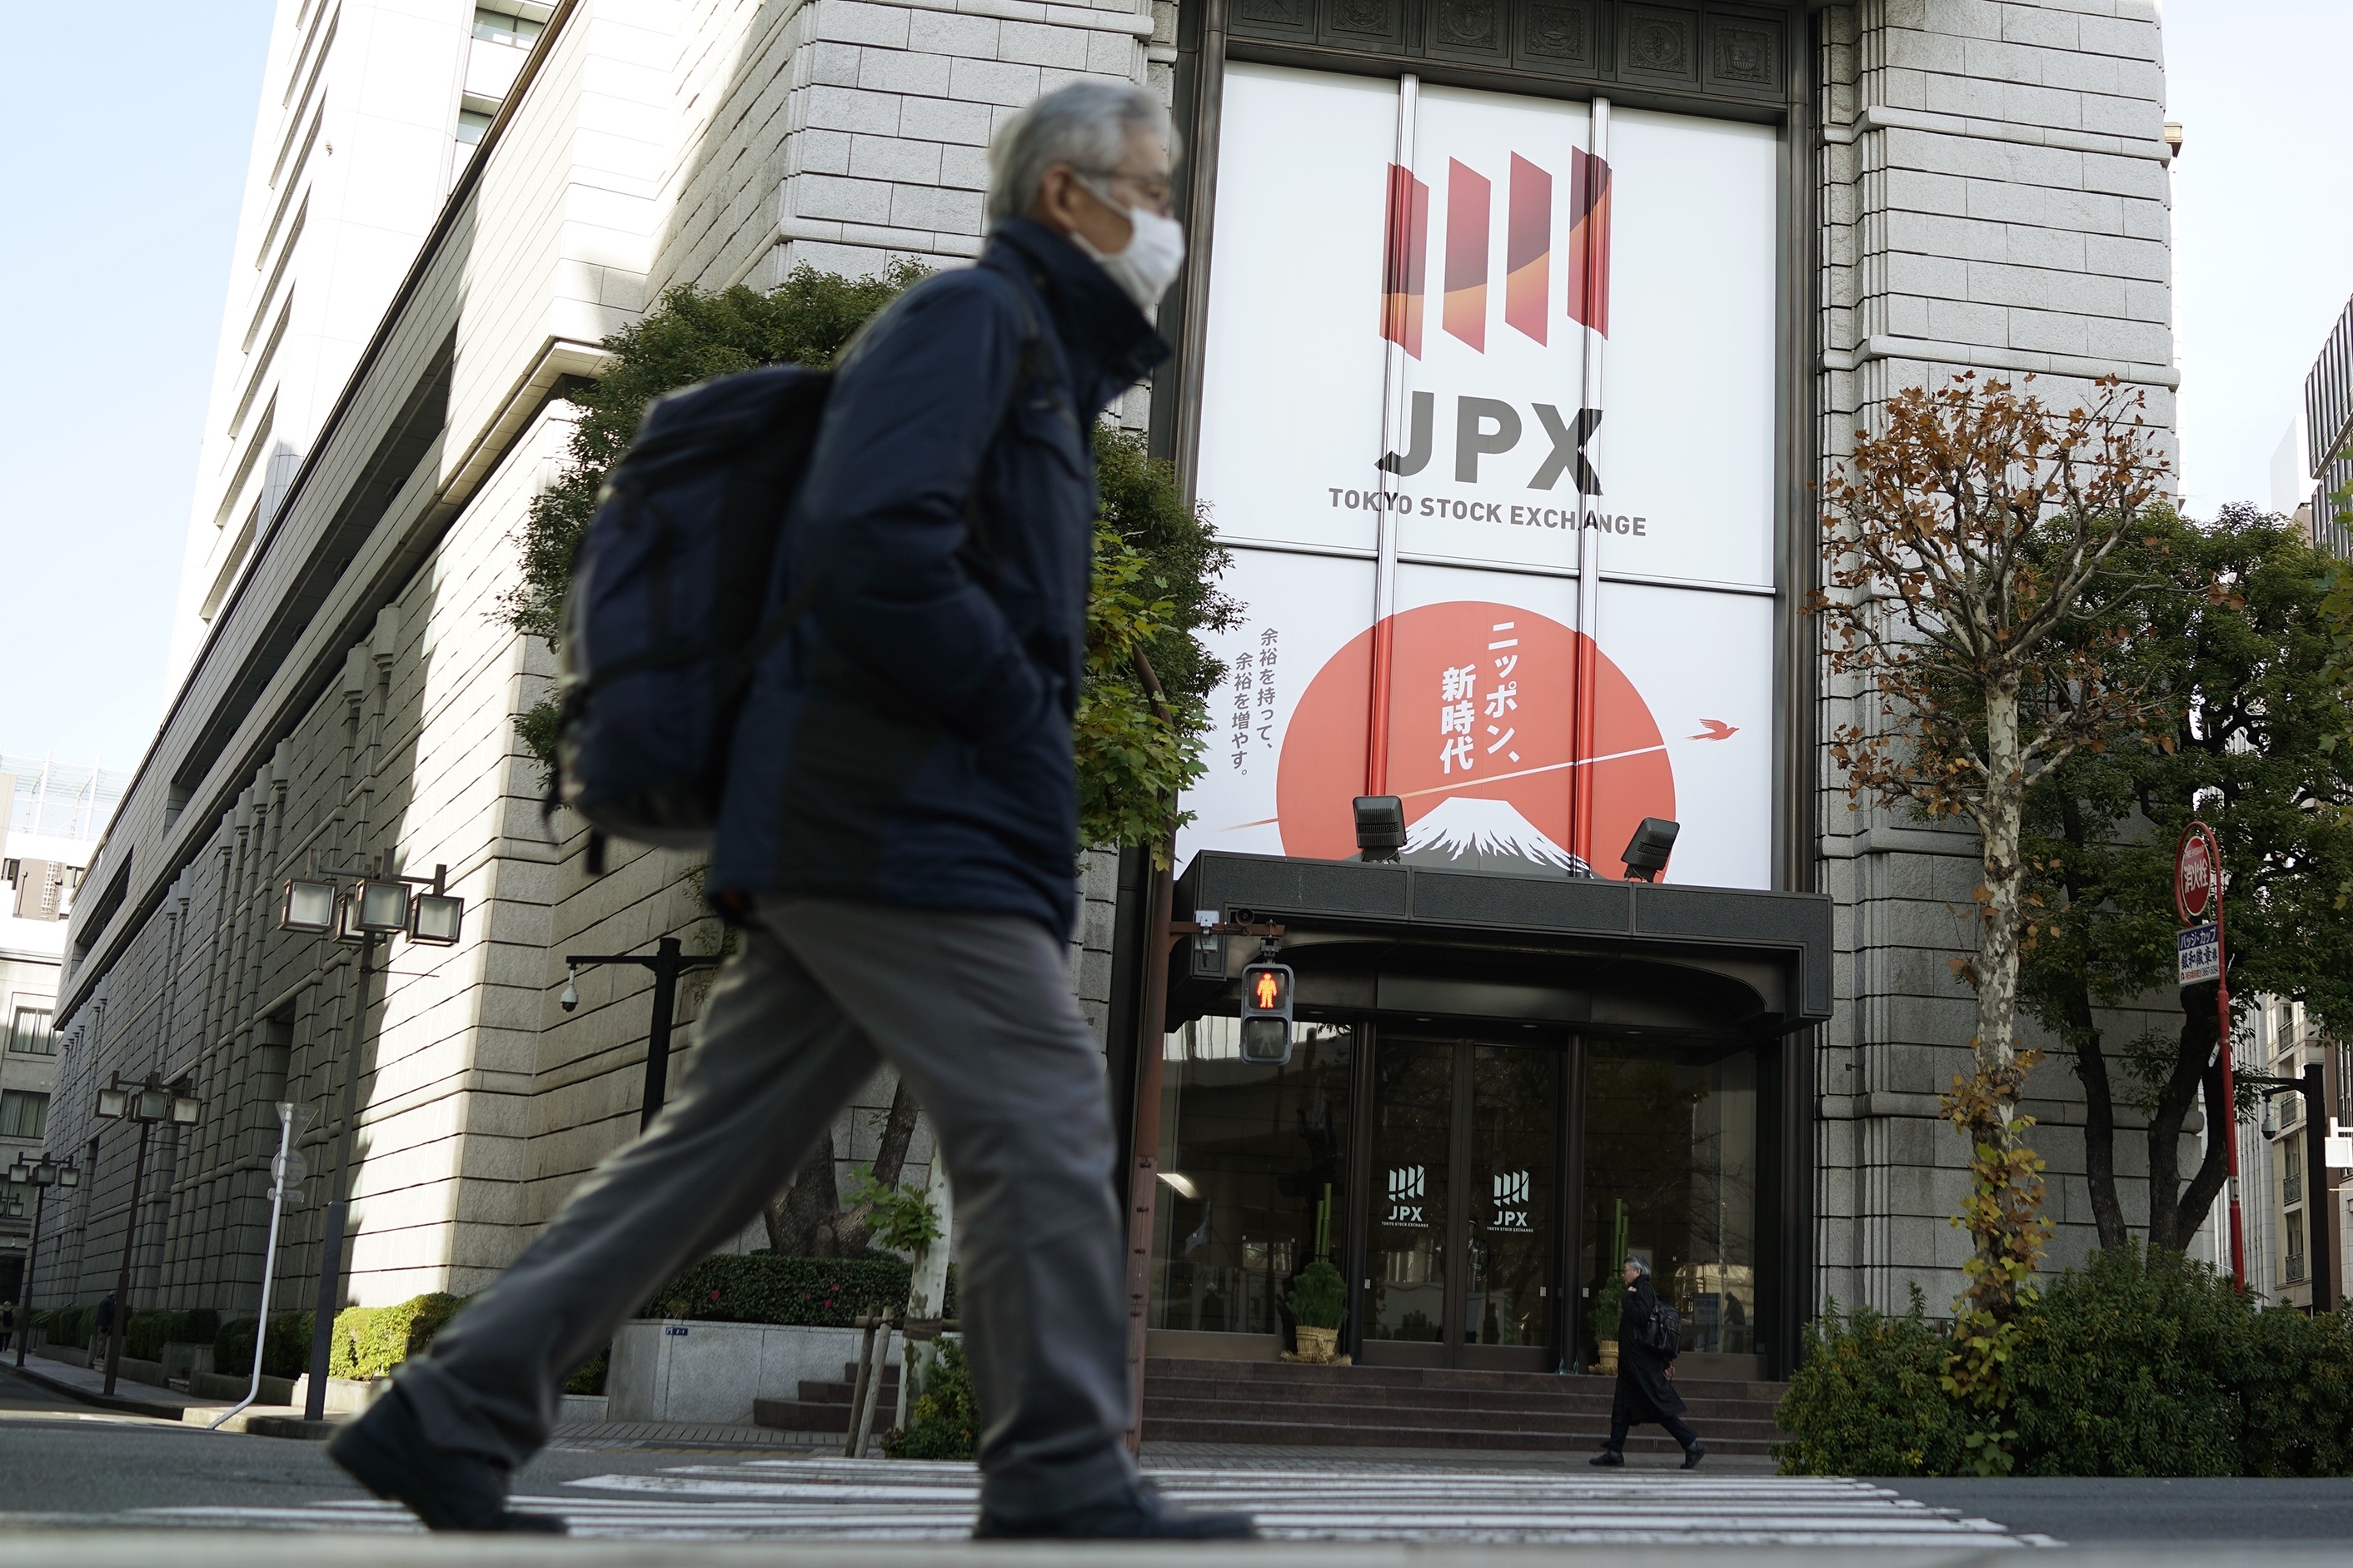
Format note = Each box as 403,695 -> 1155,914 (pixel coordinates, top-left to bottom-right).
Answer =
501,261 -> 1240,856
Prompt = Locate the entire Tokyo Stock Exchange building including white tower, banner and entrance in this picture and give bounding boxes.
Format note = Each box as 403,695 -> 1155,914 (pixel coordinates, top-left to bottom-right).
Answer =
35,0 -> 2196,1373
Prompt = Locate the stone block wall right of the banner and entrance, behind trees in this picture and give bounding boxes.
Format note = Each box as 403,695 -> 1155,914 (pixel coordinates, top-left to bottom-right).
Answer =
1814,0 -> 2196,1312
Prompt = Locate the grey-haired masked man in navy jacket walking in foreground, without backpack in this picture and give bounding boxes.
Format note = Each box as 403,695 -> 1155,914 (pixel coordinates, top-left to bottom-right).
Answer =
330,82 -> 1252,1537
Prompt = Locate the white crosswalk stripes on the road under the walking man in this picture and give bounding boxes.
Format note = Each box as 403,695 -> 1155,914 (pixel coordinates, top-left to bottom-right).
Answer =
127,1457 -> 2054,1547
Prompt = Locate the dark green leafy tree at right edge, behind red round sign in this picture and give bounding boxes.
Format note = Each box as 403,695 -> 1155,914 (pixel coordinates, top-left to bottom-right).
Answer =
2024,505 -> 2353,1251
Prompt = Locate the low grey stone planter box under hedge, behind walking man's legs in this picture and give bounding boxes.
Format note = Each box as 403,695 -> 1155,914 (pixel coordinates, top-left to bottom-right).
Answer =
605,1319 -> 904,1427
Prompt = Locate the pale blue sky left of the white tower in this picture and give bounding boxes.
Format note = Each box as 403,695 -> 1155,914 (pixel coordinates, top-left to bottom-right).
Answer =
0,0 -> 273,769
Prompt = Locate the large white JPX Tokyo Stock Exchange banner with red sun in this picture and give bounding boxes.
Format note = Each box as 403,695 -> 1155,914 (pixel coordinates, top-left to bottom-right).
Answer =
1179,63 -> 1779,886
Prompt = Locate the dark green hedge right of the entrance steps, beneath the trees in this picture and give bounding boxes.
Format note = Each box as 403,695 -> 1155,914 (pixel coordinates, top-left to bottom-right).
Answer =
1774,1246 -> 2353,1476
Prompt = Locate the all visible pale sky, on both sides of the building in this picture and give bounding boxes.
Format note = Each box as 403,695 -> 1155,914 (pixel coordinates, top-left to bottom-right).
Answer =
0,0 -> 2353,766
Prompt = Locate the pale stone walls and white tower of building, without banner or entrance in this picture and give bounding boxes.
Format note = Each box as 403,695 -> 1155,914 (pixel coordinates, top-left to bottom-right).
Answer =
35,0 -> 2176,1372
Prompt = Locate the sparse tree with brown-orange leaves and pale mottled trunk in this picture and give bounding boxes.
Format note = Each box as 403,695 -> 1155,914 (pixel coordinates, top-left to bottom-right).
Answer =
1814,371 -> 2165,1335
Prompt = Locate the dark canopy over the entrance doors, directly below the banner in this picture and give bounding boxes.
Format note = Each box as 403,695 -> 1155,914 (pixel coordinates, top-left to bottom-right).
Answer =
1167,851 -> 1831,1042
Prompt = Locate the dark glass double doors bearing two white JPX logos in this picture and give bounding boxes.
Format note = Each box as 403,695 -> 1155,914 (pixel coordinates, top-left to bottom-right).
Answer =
1363,1037 -> 1563,1371
